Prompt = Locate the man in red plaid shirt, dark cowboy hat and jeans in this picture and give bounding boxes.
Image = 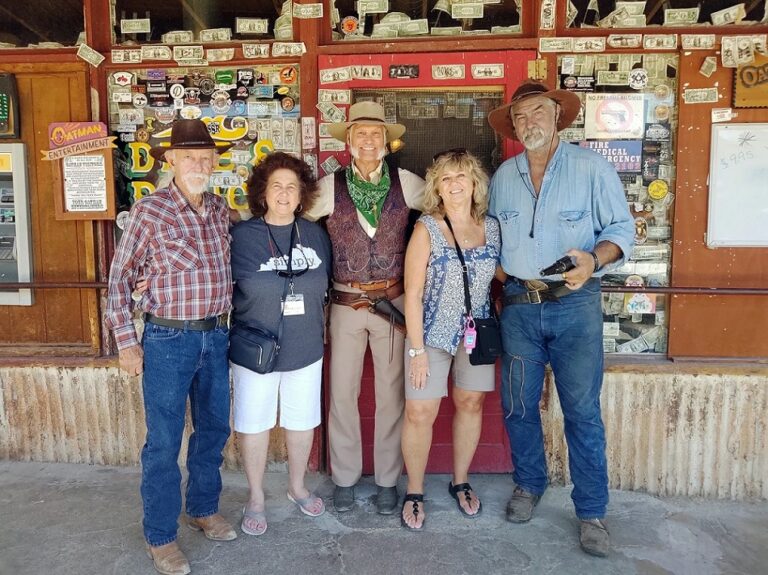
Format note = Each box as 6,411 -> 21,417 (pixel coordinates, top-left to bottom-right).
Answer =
106,120 -> 237,575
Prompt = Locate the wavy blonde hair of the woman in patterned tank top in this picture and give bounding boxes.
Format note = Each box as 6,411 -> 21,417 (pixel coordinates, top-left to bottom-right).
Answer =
424,151 -> 488,223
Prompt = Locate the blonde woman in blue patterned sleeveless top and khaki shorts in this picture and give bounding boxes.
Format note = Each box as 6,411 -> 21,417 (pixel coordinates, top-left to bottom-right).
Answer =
400,150 -> 501,530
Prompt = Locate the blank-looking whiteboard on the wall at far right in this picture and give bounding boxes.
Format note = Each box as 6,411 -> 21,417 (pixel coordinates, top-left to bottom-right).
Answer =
707,124 -> 768,248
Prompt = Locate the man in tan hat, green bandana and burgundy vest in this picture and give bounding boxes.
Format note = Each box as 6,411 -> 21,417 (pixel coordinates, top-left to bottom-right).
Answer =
308,102 -> 424,514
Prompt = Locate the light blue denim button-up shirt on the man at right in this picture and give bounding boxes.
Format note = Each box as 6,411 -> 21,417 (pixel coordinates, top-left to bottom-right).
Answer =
489,142 -> 634,279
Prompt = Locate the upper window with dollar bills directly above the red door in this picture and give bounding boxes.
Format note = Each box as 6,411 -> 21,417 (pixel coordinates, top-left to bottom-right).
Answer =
330,0 -> 523,40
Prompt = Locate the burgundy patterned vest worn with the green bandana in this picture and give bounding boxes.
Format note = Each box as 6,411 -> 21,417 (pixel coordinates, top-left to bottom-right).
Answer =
327,168 -> 409,283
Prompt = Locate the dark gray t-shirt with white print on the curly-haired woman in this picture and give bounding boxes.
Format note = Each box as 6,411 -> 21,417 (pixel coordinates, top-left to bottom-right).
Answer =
232,218 -> 332,371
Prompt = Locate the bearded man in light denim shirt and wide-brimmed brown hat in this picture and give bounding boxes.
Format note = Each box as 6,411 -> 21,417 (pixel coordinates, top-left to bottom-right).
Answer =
488,80 -> 634,556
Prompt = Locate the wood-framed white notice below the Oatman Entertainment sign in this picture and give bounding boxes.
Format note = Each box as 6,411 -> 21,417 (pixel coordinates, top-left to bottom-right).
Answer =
56,149 -> 115,220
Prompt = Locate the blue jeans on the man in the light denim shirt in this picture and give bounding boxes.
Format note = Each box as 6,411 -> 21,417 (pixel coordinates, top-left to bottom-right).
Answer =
501,278 -> 608,519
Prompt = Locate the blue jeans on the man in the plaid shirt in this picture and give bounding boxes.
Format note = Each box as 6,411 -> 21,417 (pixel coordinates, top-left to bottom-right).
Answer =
141,322 -> 230,546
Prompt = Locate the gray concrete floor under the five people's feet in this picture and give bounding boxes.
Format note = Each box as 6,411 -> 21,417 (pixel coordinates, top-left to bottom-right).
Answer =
0,462 -> 768,575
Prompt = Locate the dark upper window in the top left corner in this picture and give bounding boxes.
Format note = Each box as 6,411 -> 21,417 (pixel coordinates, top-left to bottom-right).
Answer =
0,0 -> 85,48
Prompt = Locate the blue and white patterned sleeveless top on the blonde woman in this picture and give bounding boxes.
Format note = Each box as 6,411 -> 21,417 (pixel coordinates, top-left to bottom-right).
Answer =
419,215 -> 501,355
